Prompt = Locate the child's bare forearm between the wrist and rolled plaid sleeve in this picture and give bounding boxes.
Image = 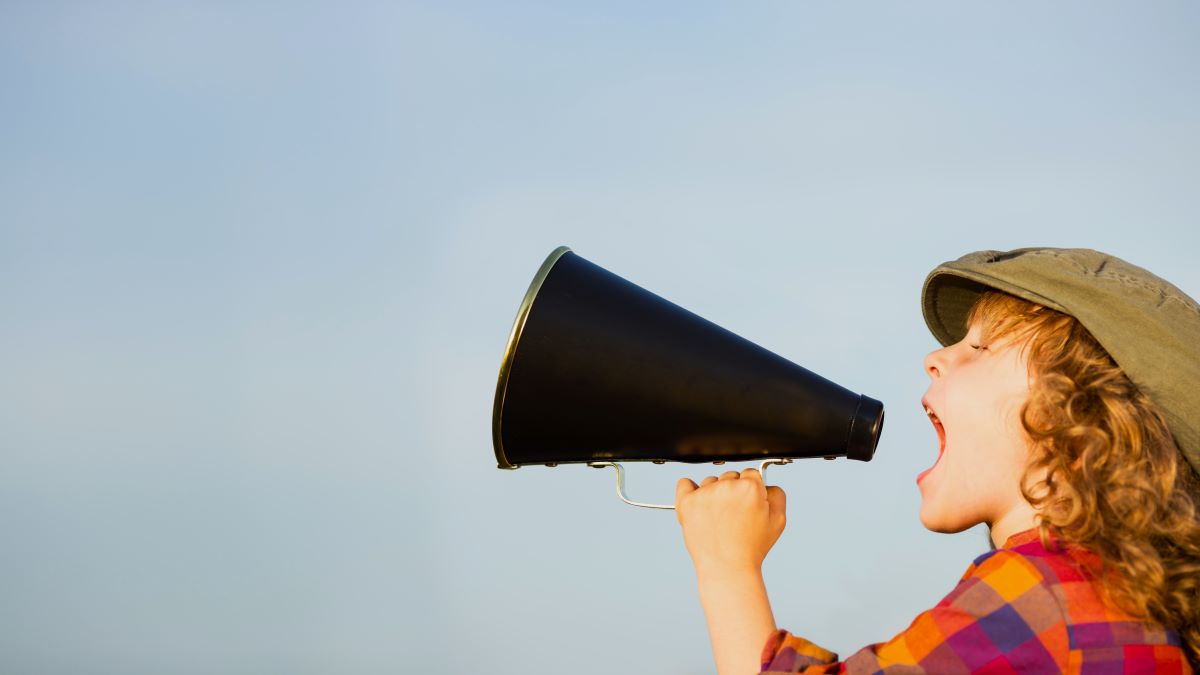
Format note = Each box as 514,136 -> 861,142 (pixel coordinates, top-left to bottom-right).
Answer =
696,562 -> 775,675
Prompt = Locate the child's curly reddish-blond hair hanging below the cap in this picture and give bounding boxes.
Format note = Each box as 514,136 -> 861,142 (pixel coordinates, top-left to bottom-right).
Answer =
967,291 -> 1200,664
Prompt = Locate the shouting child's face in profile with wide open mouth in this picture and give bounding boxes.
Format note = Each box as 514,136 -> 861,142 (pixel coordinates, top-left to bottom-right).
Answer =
917,322 -> 1030,532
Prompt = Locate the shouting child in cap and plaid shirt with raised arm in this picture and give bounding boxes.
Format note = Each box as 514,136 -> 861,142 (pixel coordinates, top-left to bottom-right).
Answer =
676,249 -> 1200,675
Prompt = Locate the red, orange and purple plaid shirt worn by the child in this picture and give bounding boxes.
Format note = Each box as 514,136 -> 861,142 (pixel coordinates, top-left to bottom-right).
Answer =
762,528 -> 1193,674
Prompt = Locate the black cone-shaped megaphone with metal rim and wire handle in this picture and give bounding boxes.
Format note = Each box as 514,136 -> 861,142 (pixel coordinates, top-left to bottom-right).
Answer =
492,246 -> 883,508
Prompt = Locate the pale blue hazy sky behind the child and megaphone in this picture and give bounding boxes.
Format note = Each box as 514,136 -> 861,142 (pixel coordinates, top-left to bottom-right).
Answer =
0,1 -> 1200,675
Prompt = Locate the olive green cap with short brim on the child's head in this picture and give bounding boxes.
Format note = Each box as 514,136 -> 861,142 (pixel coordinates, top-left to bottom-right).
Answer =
920,247 -> 1200,473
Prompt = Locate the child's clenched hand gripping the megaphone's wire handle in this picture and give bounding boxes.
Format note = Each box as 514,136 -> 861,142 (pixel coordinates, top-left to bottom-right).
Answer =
676,468 -> 787,572
